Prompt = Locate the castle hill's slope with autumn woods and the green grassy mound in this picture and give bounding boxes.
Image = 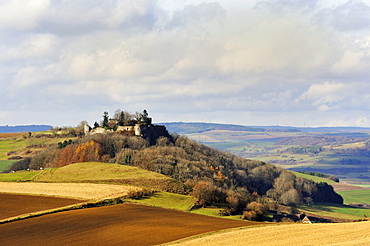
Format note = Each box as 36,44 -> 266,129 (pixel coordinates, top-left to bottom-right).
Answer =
3,129 -> 343,219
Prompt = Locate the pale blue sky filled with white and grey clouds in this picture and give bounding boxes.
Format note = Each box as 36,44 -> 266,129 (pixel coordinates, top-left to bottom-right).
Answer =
0,0 -> 370,127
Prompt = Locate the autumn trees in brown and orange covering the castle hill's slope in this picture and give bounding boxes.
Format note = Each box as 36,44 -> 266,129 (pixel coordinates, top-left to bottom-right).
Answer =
6,133 -> 343,219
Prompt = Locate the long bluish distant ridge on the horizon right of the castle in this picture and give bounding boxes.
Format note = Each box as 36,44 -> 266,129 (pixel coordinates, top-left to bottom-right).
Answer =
159,122 -> 370,134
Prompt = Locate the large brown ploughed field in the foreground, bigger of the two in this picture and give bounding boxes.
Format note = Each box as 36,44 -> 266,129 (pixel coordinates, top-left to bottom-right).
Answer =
0,204 -> 262,246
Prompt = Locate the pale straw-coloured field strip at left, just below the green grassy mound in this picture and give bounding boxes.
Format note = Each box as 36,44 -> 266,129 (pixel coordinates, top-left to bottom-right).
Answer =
0,182 -> 140,200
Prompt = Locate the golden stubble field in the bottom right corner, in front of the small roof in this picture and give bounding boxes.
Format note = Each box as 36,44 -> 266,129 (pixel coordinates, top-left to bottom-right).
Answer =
173,222 -> 370,246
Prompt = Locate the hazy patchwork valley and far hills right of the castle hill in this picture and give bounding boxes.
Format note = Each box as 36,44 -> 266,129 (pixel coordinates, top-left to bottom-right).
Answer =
163,122 -> 370,185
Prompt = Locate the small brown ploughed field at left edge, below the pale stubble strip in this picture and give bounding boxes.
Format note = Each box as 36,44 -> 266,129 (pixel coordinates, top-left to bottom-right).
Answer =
0,193 -> 82,220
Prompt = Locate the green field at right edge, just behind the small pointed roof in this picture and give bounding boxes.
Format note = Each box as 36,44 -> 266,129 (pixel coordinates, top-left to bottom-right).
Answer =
298,203 -> 370,220
